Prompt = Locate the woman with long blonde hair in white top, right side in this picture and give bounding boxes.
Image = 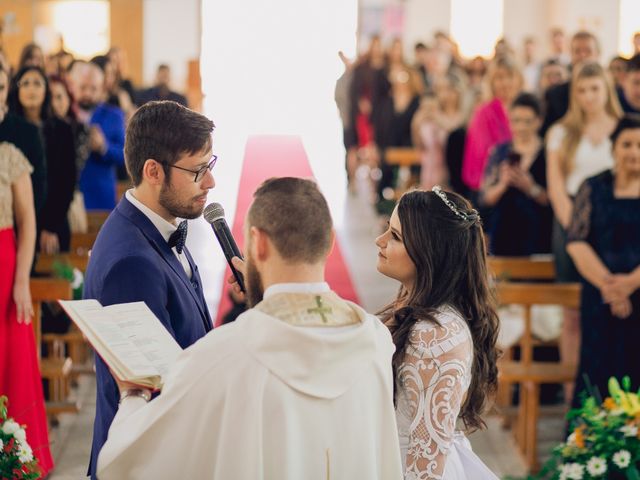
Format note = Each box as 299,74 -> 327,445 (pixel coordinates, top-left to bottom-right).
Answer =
547,62 -> 622,400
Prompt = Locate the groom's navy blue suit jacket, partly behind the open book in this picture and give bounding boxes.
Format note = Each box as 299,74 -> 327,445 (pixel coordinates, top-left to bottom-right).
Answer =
84,197 -> 213,478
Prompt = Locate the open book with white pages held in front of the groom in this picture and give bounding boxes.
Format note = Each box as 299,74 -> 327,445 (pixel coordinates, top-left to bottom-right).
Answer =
58,300 -> 182,390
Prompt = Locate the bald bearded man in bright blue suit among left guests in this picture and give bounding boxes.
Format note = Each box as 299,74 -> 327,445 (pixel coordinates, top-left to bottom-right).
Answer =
72,62 -> 124,210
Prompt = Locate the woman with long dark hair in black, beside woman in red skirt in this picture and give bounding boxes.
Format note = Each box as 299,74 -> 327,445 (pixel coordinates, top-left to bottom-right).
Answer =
9,66 -> 77,254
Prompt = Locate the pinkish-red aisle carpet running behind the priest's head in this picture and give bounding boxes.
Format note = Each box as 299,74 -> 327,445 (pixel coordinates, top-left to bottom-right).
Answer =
216,136 -> 359,325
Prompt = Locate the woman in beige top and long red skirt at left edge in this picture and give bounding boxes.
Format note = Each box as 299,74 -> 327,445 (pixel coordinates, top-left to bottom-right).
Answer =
0,64 -> 53,477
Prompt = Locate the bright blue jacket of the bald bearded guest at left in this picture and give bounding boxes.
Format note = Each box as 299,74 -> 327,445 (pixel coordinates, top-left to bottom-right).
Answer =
80,103 -> 124,210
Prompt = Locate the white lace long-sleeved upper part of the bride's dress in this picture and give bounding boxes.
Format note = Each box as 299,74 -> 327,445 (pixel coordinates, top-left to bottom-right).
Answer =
396,308 -> 473,480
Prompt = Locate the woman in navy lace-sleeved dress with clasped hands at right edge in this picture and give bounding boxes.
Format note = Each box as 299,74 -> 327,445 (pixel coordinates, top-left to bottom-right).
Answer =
567,116 -> 640,406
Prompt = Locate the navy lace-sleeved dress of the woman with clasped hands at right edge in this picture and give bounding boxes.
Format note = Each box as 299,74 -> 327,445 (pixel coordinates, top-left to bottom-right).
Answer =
568,170 -> 640,406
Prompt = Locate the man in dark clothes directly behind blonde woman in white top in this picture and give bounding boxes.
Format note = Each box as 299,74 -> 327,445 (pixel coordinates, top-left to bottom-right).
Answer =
540,31 -> 600,137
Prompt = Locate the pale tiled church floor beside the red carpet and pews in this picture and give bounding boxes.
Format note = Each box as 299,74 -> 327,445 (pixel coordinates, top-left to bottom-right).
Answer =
50,172 -> 562,480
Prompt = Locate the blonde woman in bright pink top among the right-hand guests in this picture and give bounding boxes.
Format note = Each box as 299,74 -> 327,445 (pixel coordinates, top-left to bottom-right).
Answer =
462,57 -> 522,192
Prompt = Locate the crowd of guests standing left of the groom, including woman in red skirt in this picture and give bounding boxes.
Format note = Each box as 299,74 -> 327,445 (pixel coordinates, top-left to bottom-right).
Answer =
0,44 -> 187,475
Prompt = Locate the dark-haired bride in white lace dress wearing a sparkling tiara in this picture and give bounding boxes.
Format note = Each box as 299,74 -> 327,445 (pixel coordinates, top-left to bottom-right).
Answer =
376,187 -> 498,480
